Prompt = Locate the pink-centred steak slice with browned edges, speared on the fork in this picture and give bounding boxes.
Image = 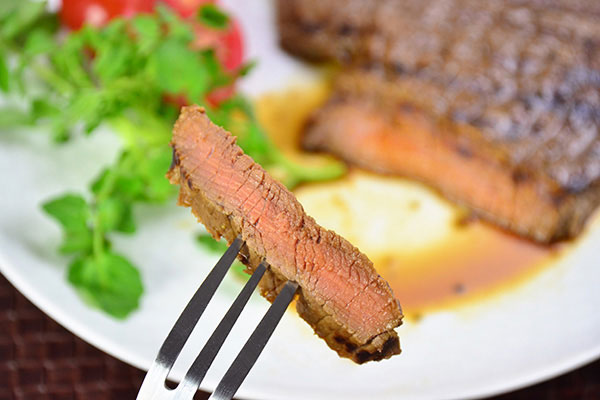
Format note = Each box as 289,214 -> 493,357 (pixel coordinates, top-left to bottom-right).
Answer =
167,106 -> 402,363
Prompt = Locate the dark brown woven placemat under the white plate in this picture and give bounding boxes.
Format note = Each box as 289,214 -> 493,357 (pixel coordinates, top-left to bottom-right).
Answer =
0,275 -> 600,400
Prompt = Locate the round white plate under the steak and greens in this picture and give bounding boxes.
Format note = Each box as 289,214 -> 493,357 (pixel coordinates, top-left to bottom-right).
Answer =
0,0 -> 600,400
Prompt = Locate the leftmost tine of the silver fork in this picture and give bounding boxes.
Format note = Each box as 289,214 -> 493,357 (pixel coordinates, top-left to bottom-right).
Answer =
137,236 -> 244,400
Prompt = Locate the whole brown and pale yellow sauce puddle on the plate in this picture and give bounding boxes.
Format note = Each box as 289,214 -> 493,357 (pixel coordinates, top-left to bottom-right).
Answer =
256,82 -> 562,319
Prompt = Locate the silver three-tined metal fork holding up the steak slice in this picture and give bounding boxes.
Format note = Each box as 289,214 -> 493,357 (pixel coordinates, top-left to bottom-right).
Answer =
137,236 -> 298,400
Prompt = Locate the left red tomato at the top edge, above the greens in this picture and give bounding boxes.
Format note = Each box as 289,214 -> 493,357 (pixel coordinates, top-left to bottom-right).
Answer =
60,0 -> 156,29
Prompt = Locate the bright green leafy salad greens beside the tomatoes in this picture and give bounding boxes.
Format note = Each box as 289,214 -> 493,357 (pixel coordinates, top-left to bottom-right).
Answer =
0,0 -> 344,318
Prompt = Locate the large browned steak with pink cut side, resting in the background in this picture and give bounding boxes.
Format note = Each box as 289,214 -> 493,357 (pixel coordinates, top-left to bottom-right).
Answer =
278,0 -> 600,242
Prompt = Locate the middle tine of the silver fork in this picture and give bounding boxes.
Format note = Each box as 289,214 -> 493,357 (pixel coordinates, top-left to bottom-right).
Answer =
174,261 -> 267,400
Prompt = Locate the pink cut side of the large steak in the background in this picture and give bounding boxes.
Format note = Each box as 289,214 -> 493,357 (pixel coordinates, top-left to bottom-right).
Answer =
303,73 -> 600,243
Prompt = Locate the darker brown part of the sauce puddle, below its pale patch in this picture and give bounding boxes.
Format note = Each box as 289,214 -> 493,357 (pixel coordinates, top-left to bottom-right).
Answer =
372,222 -> 559,317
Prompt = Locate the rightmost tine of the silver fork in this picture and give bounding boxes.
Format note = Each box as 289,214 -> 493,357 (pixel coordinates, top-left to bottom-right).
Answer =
209,281 -> 298,400
